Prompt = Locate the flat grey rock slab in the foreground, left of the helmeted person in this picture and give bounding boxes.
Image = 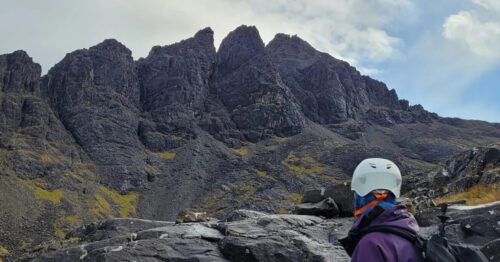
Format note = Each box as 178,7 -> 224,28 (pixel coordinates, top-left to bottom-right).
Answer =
33,210 -> 353,262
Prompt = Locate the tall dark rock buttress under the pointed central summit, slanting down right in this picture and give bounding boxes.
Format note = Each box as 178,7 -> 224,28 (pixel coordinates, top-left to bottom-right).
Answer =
214,26 -> 305,142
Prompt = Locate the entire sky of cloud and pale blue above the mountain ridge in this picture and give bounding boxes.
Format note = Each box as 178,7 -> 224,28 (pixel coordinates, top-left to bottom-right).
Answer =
0,0 -> 500,122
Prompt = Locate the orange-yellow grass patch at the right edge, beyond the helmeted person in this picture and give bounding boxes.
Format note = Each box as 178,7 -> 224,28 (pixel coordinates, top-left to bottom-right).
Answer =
434,183 -> 500,206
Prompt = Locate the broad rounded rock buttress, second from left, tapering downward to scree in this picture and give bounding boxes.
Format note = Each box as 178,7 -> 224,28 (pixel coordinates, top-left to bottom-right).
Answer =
43,40 -> 146,190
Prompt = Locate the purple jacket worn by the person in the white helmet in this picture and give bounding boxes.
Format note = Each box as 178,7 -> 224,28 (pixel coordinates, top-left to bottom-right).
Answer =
349,206 -> 423,262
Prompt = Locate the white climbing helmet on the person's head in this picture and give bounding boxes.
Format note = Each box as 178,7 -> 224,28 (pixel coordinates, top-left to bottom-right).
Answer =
351,158 -> 401,197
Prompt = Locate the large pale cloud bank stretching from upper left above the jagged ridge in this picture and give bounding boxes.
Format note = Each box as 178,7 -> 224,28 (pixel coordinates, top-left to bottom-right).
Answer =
0,0 -> 415,71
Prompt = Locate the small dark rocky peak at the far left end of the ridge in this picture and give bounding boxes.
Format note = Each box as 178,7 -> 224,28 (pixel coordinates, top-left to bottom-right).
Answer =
0,50 -> 42,94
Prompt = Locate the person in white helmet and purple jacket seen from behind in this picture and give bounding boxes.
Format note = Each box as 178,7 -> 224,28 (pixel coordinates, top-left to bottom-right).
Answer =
340,158 -> 423,262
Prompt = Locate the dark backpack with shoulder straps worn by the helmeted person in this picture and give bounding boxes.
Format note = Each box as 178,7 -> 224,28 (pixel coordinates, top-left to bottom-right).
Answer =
339,206 -> 488,262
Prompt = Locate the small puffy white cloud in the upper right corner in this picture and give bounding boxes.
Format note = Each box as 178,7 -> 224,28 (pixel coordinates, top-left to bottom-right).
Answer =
443,10 -> 500,57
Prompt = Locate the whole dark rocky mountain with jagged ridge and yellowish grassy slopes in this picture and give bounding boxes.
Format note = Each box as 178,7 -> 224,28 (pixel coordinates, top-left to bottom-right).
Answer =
0,26 -> 500,259
